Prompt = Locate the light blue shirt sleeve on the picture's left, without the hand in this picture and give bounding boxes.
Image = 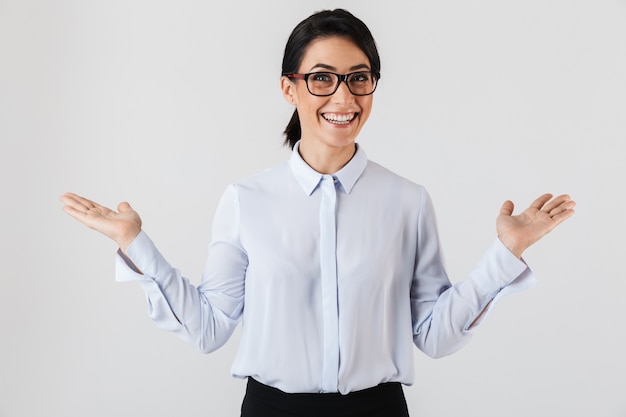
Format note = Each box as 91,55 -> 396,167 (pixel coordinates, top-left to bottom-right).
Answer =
116,186 -> 248,353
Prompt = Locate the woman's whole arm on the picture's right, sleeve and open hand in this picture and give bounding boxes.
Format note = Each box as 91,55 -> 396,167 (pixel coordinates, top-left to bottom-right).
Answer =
411,190 -> 575,357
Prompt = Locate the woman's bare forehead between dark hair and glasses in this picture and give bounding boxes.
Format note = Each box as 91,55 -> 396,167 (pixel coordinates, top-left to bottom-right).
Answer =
300,36 -> 370,72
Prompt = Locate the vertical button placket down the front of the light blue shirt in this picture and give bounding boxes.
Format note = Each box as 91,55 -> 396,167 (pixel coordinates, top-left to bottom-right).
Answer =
320,175 -> 339,392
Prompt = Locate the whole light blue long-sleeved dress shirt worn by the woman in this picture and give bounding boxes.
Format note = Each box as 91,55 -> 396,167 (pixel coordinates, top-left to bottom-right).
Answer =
116,145 -> 534,394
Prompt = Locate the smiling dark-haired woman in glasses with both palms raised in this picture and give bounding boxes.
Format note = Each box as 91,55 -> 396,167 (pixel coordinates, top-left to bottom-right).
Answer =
61,10 -> 575,417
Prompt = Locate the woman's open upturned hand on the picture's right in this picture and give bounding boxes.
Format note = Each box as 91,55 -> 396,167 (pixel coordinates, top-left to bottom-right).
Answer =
496,194 -> 576,258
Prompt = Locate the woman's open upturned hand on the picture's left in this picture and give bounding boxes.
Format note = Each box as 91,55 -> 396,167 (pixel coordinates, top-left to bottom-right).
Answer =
61,193 -> 141,252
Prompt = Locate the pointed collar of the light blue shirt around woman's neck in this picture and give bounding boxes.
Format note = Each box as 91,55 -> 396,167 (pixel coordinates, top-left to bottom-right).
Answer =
289,142 -> 367,195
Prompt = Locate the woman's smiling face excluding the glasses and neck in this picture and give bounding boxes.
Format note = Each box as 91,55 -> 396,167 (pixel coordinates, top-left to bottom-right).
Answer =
281,36 -> 373,150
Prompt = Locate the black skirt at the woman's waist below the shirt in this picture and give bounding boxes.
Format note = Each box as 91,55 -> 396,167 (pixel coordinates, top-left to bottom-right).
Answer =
241,378 -> 409,417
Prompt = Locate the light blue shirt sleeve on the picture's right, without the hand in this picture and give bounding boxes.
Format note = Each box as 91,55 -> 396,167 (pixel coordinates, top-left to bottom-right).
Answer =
411,191 -> 536,357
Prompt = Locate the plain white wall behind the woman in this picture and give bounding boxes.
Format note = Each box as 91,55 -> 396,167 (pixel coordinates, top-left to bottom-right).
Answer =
0,0 -> 626,417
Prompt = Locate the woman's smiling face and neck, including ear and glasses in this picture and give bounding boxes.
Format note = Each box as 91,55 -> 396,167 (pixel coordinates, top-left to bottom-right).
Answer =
281,35 -> 378,174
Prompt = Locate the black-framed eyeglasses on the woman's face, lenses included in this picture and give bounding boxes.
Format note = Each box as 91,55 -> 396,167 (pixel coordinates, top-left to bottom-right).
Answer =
283,71 -> 380,97
